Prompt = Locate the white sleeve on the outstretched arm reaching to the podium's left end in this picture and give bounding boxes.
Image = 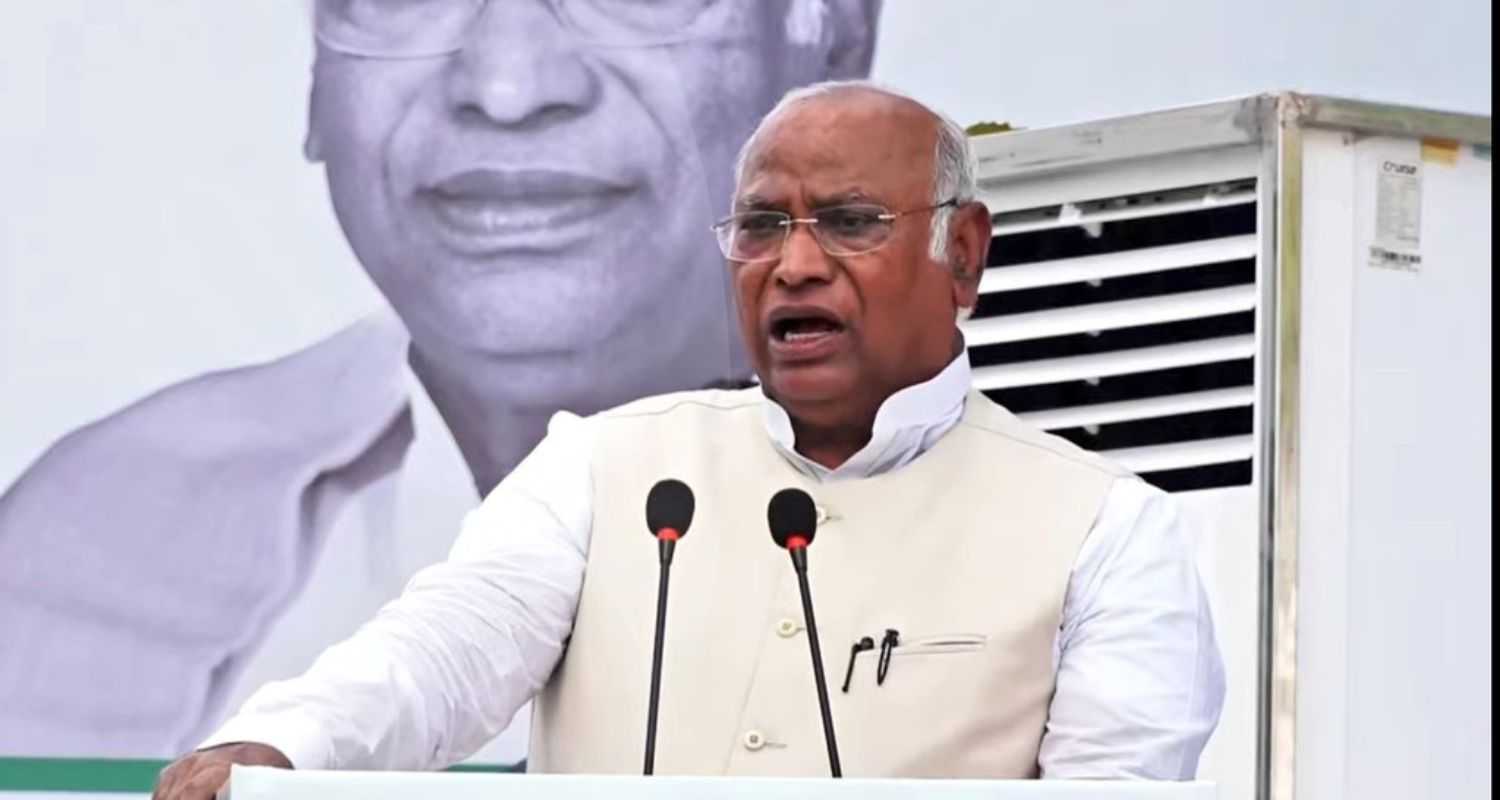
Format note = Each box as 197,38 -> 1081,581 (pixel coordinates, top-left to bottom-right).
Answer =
203,413 -> 593,770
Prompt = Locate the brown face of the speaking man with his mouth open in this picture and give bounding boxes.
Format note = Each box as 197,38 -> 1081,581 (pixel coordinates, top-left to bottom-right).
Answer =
729,92 -> 974,425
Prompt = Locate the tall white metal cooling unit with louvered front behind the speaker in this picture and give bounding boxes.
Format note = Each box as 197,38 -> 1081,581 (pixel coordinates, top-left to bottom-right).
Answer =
966,93 -> 1491,800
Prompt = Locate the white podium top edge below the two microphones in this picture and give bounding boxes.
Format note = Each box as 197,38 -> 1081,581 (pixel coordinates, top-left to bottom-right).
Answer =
219,767 -> 1217,800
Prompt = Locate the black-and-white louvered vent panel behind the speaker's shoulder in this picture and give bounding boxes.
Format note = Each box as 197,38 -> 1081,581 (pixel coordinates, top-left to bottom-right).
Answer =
965,179 -> 1260,491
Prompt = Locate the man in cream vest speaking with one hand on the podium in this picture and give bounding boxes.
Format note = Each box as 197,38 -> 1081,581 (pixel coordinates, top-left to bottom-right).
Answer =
158,84 -> 1224,800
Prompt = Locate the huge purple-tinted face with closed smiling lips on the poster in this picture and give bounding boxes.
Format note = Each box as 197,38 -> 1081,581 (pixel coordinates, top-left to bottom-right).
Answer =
309,0 -> 870,396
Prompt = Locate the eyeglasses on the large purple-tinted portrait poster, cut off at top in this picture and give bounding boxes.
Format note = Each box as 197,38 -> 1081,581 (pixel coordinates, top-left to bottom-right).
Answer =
314,0 -> 729,59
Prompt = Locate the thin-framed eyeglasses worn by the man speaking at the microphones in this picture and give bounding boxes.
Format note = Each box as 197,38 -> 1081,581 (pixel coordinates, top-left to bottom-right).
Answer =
714,198 -> 959,263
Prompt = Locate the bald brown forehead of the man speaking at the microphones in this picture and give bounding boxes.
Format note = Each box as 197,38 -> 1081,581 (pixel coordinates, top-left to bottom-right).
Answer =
735,95 -> 938,206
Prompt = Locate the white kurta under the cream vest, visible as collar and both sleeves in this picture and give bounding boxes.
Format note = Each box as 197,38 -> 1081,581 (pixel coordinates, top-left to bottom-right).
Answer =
204,356 -> 1224,779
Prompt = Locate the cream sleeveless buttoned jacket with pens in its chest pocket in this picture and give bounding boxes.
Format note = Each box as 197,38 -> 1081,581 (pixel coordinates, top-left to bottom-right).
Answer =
530,389 -> 1127,777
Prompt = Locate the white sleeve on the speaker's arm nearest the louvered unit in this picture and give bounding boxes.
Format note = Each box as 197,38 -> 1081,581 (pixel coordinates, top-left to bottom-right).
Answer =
1038,479 -> 1224,780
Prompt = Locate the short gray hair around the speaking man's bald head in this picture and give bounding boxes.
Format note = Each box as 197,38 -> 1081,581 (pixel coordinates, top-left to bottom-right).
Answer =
735,81 -> 978,263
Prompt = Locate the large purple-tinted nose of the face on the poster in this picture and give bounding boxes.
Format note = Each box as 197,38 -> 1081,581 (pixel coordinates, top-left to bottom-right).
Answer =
449,0 -> 600,125
